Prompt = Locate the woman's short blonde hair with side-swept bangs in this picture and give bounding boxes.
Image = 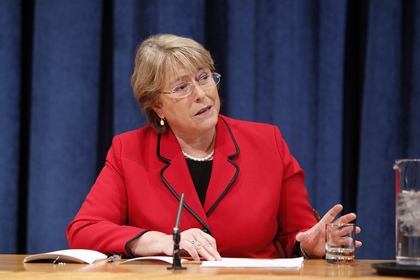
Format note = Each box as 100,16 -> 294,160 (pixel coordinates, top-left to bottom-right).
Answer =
131,34 -> 215,133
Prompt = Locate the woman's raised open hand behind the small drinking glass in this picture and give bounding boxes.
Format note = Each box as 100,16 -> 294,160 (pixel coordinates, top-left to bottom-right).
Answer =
296,204 -> 362,257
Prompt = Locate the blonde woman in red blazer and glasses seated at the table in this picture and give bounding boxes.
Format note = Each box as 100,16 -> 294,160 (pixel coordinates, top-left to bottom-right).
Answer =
67,34 -> 361,260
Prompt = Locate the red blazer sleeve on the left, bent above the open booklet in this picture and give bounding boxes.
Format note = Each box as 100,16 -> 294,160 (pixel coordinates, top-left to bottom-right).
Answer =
66,136 -> 146,255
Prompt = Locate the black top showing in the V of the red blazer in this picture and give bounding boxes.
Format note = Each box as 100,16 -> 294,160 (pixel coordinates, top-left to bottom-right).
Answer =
186,158 -> 213,206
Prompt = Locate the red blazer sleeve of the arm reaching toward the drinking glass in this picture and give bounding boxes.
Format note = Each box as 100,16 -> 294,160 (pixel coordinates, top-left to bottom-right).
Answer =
275,127 -> 317,257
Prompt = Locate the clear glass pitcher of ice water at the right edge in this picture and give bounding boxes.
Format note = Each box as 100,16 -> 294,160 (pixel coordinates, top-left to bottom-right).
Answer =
394,159 -> 420,266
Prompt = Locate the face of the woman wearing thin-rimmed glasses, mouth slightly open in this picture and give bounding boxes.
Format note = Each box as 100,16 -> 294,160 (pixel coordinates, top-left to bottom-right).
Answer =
153,69 -> 220,139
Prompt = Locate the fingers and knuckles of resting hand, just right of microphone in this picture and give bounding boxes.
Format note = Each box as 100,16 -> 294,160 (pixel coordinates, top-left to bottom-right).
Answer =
180,229 -> 222,261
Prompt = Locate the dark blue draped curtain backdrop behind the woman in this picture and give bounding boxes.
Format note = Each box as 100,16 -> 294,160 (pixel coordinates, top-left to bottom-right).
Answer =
0,0 -> 420,259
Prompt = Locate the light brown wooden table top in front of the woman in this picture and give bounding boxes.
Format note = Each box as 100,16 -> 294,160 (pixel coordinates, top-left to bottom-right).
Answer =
0,255 -> 416,280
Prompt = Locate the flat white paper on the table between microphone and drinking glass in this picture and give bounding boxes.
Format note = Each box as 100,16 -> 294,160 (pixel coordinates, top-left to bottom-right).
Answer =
201,257 -> 303,268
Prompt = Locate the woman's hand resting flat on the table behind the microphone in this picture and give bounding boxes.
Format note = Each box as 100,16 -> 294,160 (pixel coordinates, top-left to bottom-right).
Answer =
129,228 -> 222,261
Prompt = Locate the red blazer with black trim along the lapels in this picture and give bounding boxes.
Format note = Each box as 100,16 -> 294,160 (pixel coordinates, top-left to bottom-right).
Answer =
67,116 -> 317,258
